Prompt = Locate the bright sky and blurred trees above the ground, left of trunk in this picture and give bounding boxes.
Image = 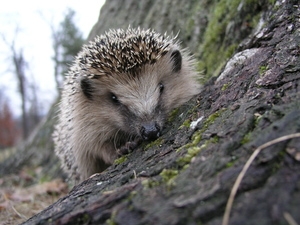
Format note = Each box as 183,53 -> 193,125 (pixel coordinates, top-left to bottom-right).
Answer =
0,1 -> 103,150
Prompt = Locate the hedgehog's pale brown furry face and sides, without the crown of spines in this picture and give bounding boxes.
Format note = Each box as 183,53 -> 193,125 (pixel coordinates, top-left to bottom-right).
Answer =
54,28 -> 200,184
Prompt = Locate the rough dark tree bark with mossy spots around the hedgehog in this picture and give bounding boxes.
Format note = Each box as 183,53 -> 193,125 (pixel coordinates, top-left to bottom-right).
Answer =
20,0 -> 300,225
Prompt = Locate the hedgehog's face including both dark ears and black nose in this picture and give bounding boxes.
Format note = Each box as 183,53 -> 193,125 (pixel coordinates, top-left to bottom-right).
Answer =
81,50 -> 183,140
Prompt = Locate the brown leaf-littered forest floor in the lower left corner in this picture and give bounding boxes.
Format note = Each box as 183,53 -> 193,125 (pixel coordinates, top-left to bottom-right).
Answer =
0,149 -> 68,225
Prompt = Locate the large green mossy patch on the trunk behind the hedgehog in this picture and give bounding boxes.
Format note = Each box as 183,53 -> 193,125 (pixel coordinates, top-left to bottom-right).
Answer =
197,0 -> 261,79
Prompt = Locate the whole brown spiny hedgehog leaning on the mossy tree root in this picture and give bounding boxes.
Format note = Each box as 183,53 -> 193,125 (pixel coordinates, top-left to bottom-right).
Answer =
53,28 -> 201,184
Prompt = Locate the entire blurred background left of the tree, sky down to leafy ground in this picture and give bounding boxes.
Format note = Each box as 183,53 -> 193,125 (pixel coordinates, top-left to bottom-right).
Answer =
0,0 -> 104,224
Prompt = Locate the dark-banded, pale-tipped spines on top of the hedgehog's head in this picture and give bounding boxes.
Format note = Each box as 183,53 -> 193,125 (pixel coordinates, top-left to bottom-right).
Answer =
74,28 -> 176,74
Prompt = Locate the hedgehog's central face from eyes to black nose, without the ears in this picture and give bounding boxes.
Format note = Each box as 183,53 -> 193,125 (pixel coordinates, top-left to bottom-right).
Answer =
109,75 -> 166,140
